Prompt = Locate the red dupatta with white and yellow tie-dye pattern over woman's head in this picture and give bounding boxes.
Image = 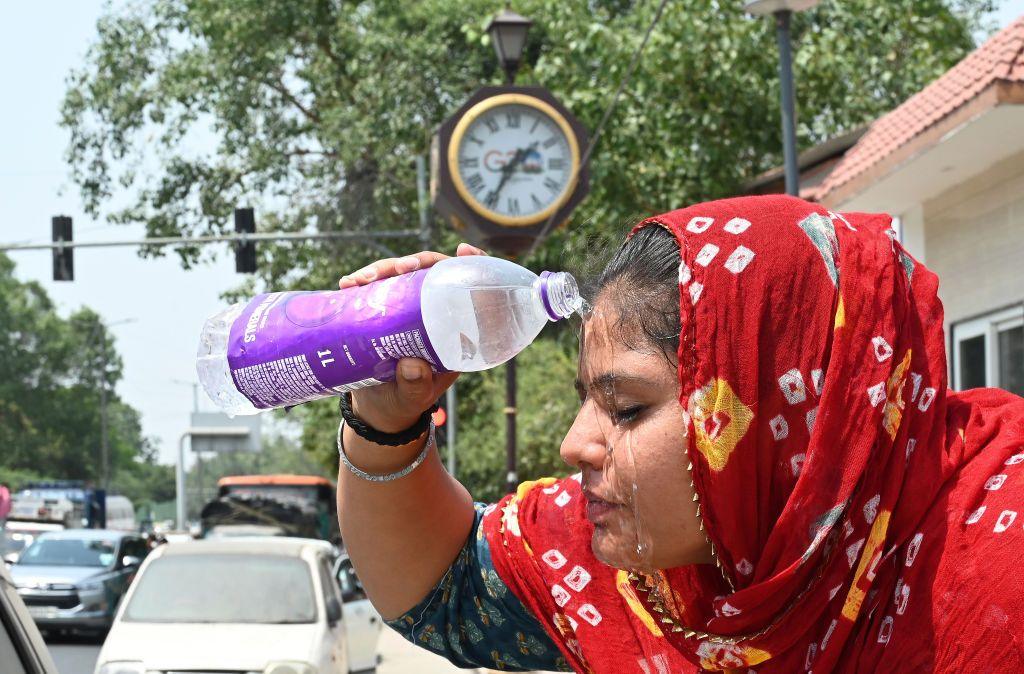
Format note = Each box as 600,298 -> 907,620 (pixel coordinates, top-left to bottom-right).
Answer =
483,191 -> 1024,674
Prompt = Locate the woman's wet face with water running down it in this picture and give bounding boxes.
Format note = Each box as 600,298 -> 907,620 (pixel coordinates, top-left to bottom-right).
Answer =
561,293 -> 712,570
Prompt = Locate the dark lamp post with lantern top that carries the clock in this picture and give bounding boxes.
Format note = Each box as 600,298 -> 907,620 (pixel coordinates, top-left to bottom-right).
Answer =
487,4 -> 534,492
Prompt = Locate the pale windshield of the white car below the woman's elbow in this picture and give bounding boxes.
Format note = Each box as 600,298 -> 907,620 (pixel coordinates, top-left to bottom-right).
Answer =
123,554 -> 316,624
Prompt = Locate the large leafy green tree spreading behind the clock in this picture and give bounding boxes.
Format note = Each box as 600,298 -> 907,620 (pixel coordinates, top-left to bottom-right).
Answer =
62,0 -> 995,489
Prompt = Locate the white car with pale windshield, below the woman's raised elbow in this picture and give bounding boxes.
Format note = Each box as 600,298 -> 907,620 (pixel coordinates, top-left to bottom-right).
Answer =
96,537 -> 381,674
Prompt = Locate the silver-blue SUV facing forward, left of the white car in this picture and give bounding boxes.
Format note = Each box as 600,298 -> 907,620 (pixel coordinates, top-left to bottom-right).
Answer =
10,529 -> 148,633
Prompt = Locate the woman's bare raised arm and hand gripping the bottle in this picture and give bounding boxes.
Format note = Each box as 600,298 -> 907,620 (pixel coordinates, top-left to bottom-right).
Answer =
338,244 -> 484,620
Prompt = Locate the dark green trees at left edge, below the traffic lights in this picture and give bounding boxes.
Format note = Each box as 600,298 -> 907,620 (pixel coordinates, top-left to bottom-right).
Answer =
0,253 -> 157,489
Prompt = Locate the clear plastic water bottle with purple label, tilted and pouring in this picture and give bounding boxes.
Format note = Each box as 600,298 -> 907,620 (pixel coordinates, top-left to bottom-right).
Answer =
196,255 -> 580,415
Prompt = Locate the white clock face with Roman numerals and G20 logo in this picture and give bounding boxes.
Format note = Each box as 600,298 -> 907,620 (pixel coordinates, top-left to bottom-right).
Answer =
452,98 -> 579,224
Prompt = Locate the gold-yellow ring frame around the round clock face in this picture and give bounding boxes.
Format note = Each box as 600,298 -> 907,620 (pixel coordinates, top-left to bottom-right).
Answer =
447,93 -> 580,227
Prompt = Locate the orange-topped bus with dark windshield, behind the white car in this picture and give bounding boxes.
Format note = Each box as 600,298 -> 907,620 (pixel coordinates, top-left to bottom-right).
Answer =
201,474 -> 341,544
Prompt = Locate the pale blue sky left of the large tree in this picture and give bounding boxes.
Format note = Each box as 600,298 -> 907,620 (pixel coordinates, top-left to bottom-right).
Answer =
6,0 -> 1024,463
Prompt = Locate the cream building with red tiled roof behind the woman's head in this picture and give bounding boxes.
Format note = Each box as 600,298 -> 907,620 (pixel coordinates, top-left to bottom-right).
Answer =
745,16 -> 1024,394
